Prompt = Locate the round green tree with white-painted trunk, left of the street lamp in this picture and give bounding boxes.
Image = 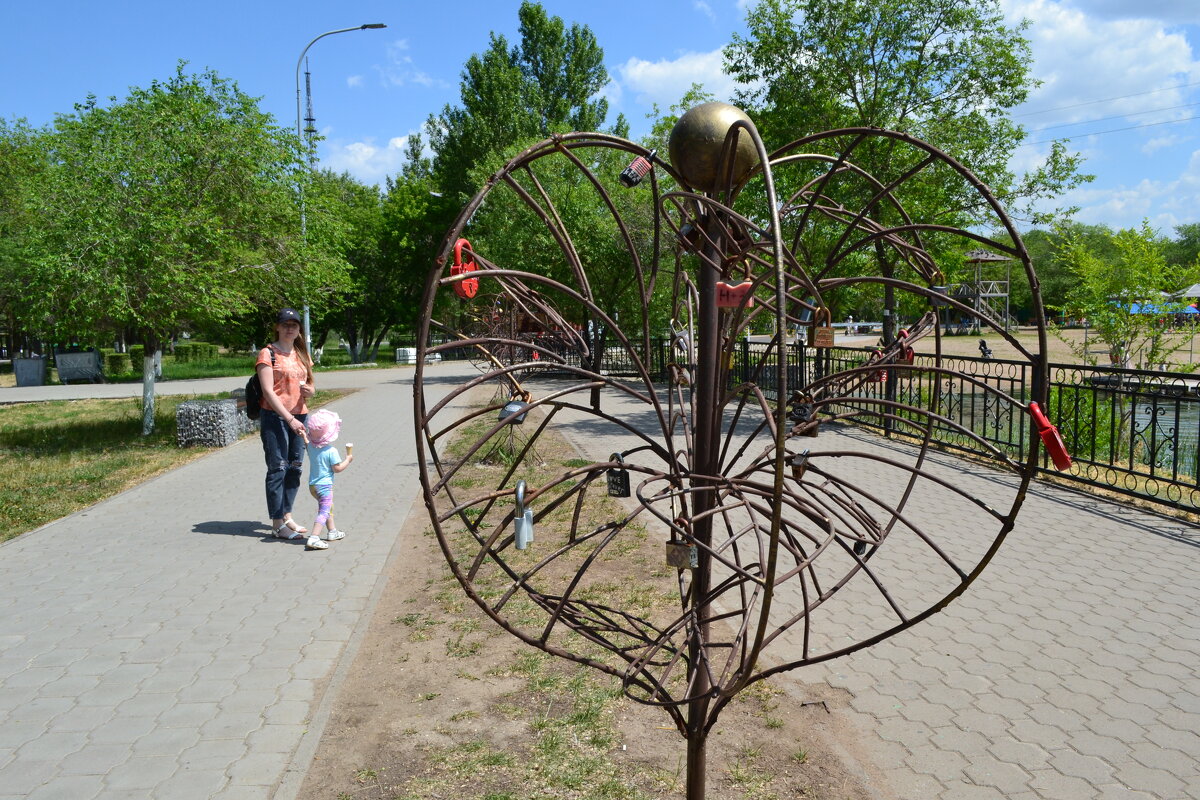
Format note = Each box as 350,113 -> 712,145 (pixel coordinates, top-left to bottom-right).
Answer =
25,62 -> 344,433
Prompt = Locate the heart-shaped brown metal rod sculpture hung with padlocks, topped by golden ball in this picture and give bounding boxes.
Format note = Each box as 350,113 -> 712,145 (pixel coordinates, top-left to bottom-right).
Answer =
415,103 -> 1070,800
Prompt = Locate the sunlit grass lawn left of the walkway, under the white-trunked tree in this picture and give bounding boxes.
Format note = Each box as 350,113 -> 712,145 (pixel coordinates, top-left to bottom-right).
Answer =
0,391 -> 344,541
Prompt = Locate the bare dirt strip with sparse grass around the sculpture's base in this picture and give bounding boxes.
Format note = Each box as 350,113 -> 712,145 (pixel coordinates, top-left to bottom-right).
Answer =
299,407 -> 884,800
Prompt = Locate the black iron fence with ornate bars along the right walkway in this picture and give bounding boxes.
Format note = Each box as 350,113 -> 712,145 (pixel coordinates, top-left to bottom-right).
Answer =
417,338 -> 1200,511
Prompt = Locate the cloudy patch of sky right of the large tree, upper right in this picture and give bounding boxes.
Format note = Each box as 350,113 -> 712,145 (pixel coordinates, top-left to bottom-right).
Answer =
1002,0 -> 1200,228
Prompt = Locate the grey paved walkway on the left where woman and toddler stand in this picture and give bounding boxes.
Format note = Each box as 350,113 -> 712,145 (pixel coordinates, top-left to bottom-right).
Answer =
0,367 -> 458,800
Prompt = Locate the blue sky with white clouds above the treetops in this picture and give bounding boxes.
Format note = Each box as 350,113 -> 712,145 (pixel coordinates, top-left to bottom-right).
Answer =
0,0 -> 1200,235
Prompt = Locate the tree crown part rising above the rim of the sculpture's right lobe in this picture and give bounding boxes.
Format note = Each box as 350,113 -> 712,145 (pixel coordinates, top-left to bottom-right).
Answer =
725,0 -> 1090,225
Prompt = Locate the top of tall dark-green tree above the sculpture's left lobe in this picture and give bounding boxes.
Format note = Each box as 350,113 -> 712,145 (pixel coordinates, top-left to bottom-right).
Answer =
426,0 -> 628,199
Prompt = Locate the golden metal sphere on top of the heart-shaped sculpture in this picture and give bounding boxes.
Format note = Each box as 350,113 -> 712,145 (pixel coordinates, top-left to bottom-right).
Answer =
667,103 -> 758,192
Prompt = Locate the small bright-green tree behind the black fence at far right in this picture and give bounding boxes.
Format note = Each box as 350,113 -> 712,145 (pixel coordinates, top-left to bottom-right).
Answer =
1057,222 -> 1200,369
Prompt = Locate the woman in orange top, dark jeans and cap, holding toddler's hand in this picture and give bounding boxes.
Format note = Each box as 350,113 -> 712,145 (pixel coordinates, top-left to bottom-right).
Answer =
254,308 -> 329,549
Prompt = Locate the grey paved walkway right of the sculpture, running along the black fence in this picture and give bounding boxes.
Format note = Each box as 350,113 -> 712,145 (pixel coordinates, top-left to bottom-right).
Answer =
549,383 -> 1200,800
